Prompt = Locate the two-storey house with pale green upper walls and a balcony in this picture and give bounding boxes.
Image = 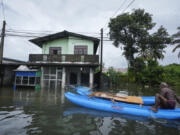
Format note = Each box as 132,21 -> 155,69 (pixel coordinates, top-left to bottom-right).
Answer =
29,31 -> 99,88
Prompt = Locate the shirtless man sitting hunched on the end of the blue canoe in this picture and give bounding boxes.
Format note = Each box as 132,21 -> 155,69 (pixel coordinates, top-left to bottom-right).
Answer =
151,82 -> 180,112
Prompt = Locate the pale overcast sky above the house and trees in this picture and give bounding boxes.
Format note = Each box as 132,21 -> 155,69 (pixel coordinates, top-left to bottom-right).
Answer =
0,0 -> 180,68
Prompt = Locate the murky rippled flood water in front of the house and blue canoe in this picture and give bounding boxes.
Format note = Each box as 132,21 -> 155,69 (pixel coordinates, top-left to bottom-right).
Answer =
0,88 -> 180,135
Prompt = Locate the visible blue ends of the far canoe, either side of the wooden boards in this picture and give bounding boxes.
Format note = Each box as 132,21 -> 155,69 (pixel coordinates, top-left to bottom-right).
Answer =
75,86 -> 155,105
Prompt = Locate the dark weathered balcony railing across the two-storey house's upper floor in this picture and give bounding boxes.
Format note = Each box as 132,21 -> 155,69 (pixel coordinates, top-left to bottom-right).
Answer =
29,54 -> 99,64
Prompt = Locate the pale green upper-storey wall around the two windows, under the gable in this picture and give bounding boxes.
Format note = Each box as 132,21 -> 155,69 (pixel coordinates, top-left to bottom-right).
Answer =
42,37 -> 94,54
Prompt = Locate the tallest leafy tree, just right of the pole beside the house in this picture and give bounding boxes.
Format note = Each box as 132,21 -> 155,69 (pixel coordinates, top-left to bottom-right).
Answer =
109,9 -> 155,66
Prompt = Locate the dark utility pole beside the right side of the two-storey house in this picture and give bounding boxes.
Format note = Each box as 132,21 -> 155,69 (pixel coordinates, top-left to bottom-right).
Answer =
100,28 -> 104,88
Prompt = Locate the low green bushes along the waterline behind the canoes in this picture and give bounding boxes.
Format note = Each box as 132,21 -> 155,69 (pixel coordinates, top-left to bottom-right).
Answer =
105,62 -> 180,89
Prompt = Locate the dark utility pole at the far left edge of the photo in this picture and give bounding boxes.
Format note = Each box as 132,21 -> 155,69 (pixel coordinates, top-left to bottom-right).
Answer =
0,20 -> 6,64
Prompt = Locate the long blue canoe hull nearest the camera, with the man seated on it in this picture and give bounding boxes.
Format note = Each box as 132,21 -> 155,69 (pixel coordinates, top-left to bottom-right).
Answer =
65,92 -> 180,120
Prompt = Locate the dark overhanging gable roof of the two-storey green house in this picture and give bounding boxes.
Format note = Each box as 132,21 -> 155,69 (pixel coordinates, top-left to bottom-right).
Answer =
29,30 -> 100,52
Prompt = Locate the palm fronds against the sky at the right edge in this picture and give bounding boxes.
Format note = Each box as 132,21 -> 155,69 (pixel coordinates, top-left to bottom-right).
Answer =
172,27 -> 180,58
